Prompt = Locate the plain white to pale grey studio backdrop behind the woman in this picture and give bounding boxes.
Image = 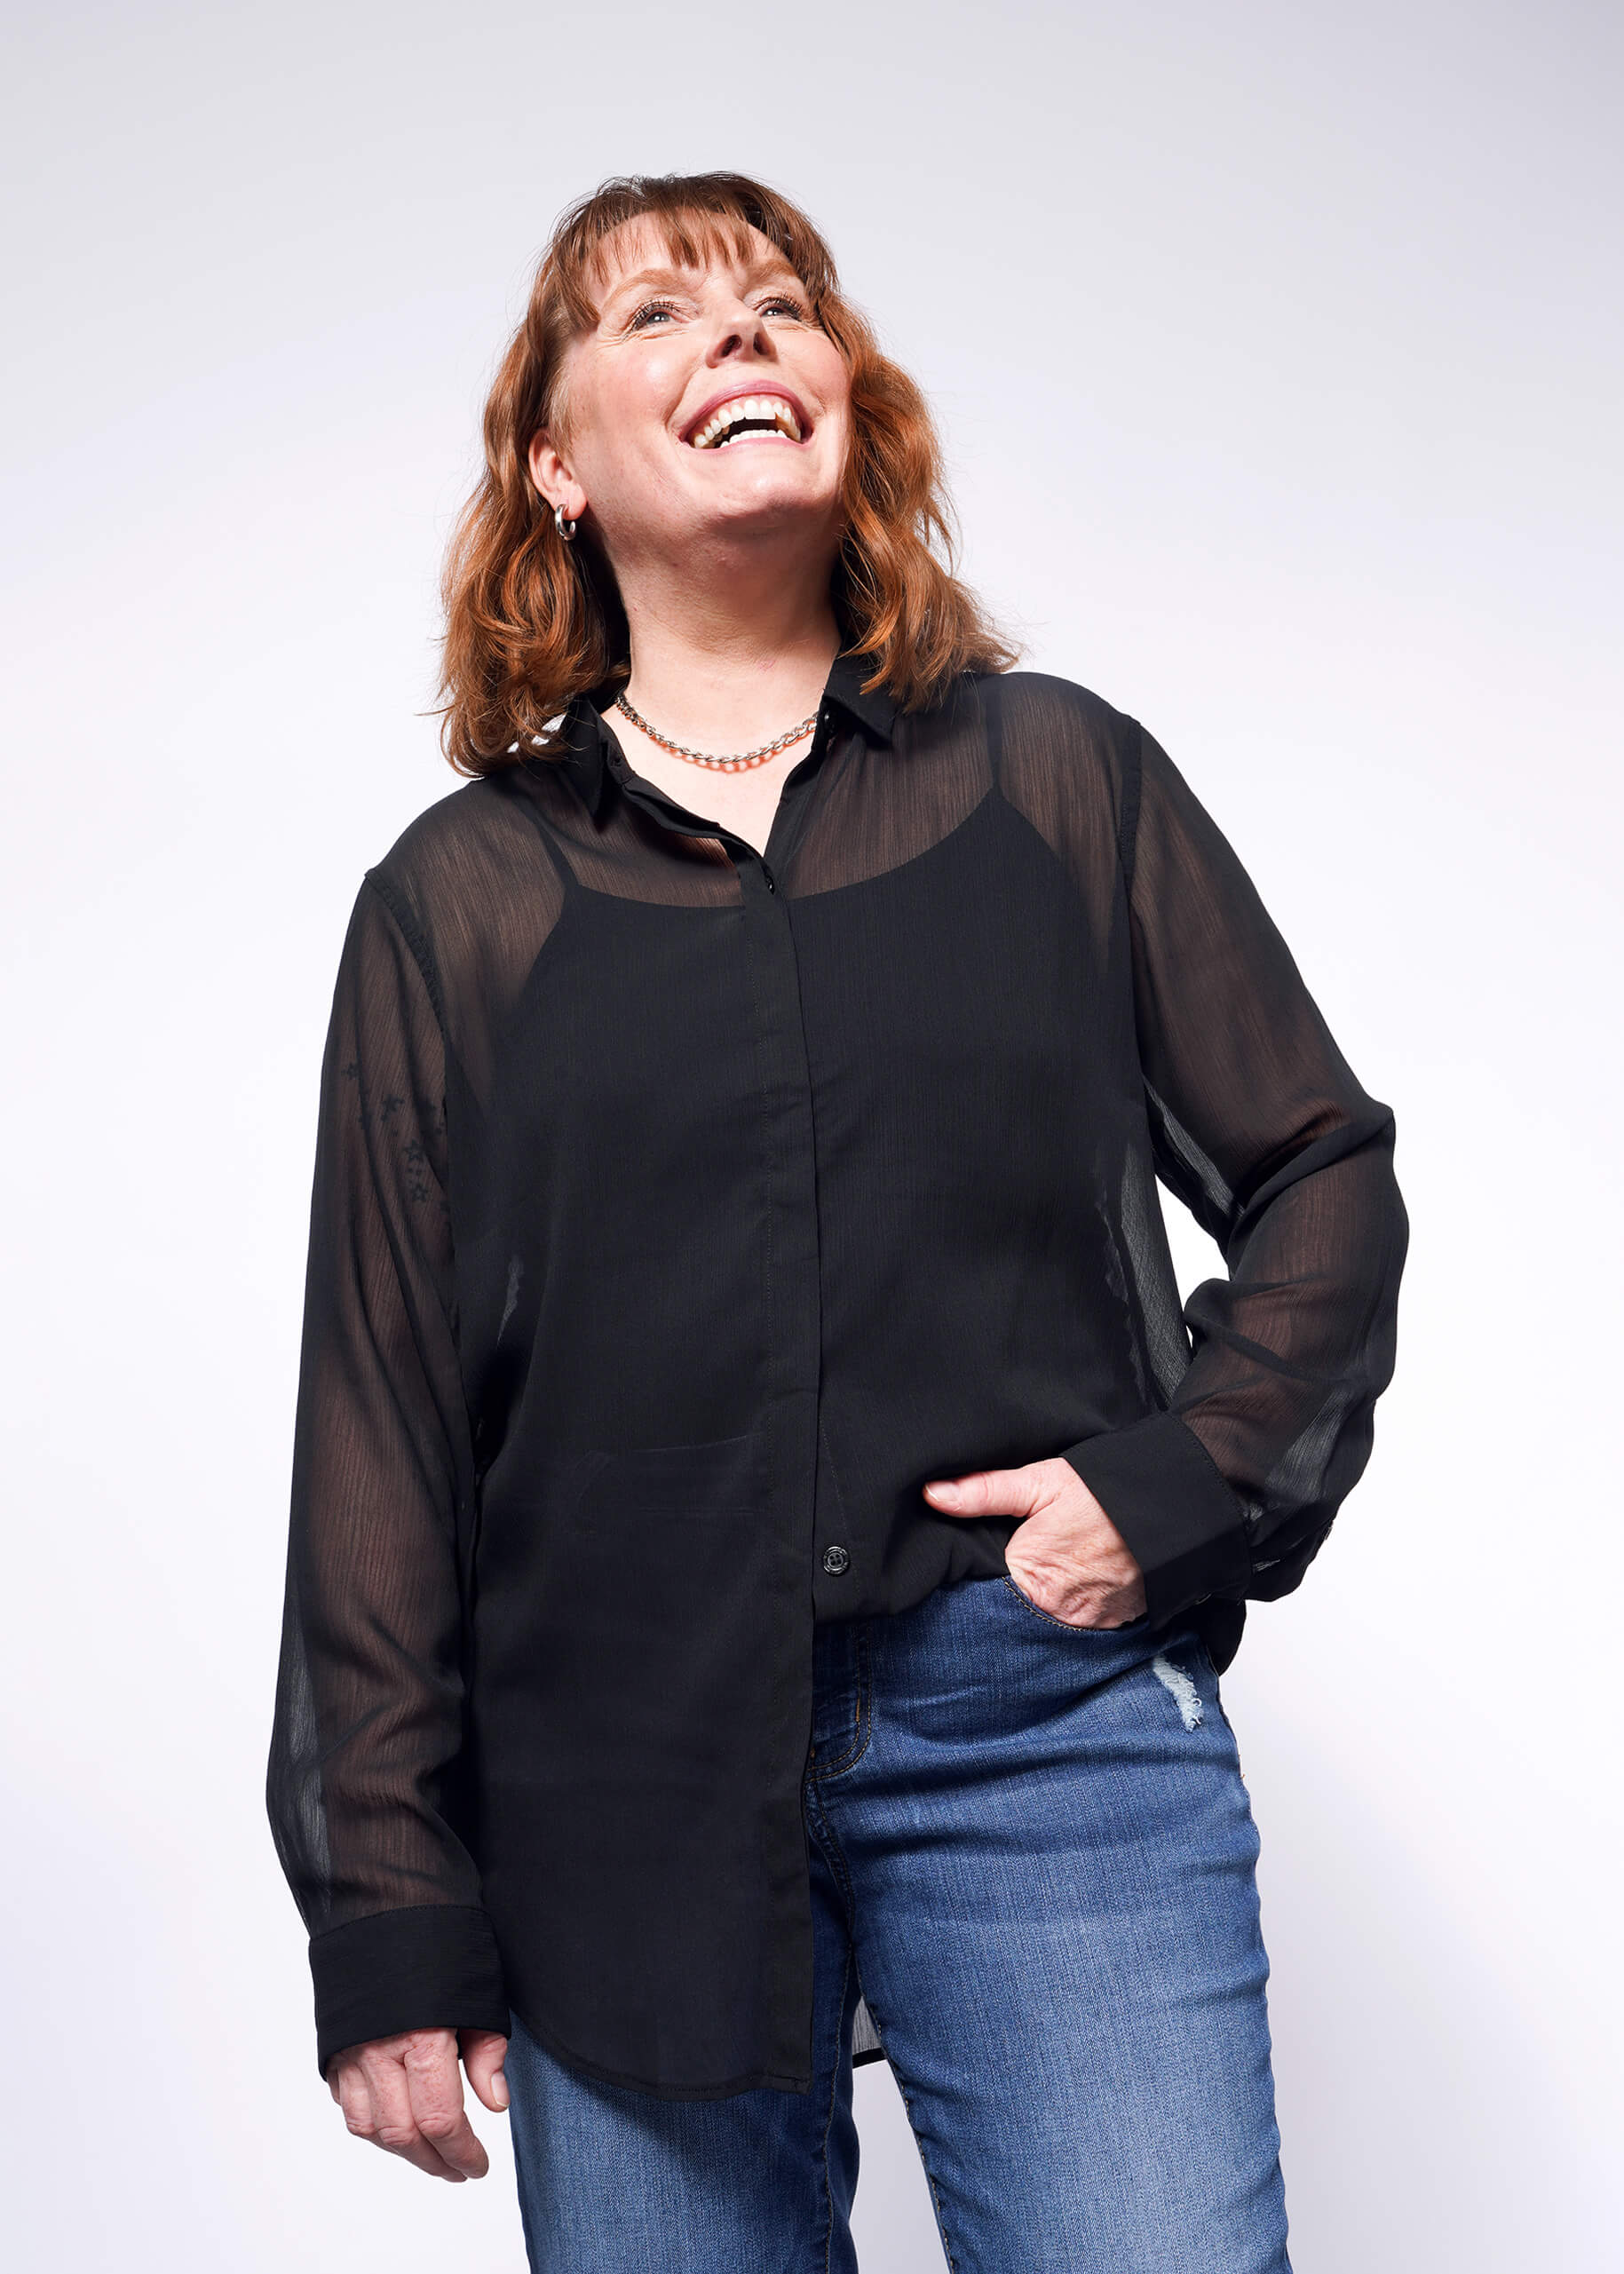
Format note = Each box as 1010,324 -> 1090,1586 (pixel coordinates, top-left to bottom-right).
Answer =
0,0 -> 1624,2274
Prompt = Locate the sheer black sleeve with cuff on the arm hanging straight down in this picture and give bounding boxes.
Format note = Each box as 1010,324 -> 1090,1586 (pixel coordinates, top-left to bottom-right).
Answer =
266,876 -> 507,2074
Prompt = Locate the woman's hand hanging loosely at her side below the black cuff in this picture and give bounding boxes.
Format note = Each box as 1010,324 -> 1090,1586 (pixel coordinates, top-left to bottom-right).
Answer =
328,2028 -> 507,2183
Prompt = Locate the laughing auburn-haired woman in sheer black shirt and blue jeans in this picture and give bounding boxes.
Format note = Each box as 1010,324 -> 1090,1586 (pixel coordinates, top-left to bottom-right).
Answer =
271,175 -> 1406,2274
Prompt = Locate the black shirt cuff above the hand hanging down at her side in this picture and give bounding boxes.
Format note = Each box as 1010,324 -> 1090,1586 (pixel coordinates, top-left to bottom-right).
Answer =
309,1904 -> 511,2076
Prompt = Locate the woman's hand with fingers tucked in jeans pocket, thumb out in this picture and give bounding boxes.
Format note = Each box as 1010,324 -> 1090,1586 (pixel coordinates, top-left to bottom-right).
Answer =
926,1460 -> 1146,1626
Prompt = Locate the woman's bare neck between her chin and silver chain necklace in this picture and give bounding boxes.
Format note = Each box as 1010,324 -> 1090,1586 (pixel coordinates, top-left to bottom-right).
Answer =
616,529 -> 839,750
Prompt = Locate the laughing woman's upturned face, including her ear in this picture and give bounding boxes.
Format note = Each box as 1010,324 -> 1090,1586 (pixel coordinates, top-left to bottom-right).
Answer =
530,220 -> 851,571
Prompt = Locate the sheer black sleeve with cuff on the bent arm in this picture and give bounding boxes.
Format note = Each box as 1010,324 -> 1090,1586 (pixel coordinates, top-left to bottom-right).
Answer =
1066,734 -> 1408,1621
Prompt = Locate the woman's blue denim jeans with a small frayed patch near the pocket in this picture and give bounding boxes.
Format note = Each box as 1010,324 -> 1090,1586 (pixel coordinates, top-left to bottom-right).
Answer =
507,1578 -> 1289,2274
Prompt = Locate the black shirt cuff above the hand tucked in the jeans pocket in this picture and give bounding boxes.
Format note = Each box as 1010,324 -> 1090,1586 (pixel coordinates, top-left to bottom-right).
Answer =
1060,1412 -> 1251,1626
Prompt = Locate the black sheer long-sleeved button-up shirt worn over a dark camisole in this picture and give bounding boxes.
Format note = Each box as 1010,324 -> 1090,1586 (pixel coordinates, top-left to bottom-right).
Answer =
268,657 -> 1408,2096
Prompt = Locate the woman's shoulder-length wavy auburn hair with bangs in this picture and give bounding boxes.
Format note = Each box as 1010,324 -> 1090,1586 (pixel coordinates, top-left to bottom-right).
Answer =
439,173 -> 1017,775
